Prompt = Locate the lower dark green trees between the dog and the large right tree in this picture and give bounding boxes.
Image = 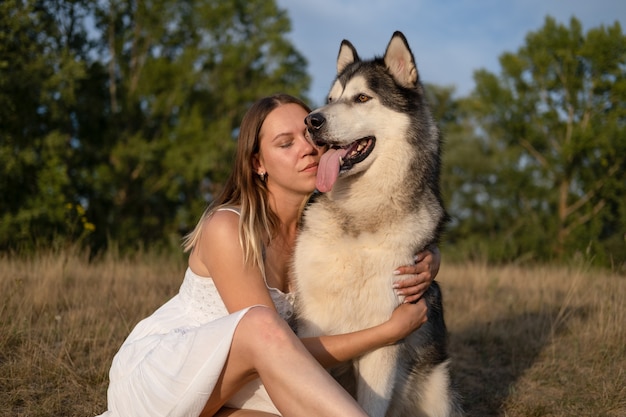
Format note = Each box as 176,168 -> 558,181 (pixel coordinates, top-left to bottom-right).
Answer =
427,85 -> 517,261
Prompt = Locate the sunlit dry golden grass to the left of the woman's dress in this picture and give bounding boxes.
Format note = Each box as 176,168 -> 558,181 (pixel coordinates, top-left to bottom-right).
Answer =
0,250 -> 183,417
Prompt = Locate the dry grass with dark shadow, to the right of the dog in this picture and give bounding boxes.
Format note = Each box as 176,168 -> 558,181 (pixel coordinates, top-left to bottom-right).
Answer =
437,264 -> 626,417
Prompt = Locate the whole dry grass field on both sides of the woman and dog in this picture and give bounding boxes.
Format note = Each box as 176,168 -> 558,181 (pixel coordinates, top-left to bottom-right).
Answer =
0,250 -> 626,417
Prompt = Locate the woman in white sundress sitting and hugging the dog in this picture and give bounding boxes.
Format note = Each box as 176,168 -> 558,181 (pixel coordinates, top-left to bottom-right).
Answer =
98,95 -> 439,416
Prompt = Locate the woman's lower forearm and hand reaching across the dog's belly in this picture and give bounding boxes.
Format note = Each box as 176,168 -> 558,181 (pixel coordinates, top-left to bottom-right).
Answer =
301,300 -> 427,368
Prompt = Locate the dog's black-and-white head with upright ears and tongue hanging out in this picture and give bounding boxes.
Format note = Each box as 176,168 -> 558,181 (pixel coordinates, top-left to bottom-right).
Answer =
306,32 -> 431,192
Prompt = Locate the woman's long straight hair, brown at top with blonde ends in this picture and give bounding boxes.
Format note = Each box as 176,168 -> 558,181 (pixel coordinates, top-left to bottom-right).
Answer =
183,94 -> 311,275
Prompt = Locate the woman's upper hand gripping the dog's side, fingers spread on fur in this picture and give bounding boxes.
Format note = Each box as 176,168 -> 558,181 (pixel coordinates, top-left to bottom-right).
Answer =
393,246 -> 441,303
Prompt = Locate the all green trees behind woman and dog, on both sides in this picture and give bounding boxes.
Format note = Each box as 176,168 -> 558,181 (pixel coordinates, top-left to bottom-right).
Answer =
0,0 -> 626,271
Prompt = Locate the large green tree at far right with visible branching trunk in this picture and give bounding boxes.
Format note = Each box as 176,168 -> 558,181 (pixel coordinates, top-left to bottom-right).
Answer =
457,17 -> 626,265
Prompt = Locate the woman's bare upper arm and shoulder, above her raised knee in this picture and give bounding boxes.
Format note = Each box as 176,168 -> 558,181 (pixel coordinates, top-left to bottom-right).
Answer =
189,210 -> 276,313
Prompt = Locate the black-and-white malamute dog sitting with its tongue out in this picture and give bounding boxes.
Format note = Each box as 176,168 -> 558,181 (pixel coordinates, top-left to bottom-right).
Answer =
293,32 -> 461,417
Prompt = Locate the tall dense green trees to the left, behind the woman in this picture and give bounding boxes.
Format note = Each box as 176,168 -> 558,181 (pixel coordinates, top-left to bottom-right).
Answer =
0,0 -> 309,249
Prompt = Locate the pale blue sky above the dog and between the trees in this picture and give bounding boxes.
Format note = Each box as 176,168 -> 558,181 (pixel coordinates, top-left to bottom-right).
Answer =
278,0 -> 626,104
